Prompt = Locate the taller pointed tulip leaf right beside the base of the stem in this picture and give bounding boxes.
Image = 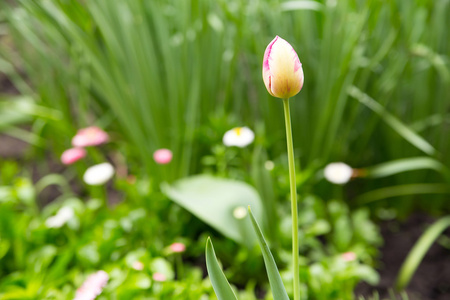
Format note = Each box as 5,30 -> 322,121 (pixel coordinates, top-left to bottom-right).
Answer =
248,207 -> 289,300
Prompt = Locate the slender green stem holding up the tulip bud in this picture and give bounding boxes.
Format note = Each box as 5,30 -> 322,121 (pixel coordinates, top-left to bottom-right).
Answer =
283,99 -> 300,300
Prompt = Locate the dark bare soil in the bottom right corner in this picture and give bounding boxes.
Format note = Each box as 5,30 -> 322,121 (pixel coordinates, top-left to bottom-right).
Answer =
355,214 -> 450,300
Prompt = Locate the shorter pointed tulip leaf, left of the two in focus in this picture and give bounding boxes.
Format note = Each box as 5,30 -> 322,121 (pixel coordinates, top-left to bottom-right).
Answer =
206,237 -> 237,300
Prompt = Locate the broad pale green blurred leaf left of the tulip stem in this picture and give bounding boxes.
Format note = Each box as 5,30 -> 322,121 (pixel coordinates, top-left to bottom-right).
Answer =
162,175 -> 263,245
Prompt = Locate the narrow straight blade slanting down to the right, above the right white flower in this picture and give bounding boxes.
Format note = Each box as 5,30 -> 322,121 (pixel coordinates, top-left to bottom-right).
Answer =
348,86 -> 436,155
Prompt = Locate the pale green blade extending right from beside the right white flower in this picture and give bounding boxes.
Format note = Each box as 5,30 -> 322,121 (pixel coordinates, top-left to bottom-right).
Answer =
366,156 -> 450,181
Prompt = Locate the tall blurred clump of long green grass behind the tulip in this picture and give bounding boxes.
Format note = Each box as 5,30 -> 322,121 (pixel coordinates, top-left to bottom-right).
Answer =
1,0 -> 450,207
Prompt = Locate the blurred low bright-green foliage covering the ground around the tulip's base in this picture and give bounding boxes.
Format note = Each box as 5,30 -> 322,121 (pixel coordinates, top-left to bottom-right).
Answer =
0,161 -> 380,300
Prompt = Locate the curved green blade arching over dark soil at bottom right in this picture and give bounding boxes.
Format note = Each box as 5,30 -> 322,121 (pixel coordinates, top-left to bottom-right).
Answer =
395,216 -> 450,290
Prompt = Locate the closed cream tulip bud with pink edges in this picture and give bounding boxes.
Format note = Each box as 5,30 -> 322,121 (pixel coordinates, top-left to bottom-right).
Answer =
263,36 -> 304,99
